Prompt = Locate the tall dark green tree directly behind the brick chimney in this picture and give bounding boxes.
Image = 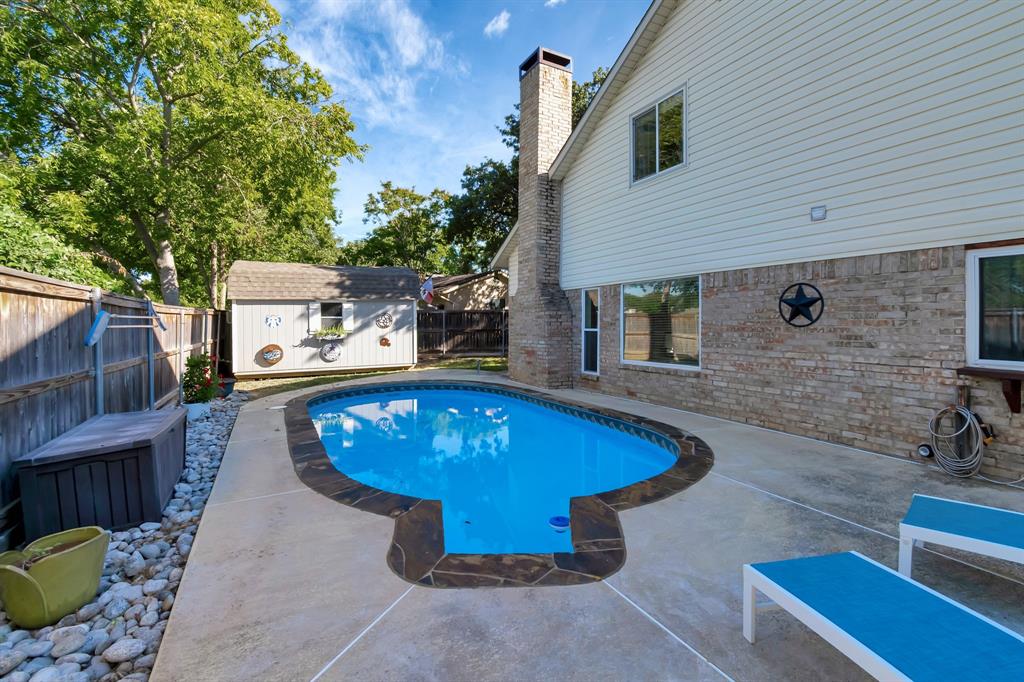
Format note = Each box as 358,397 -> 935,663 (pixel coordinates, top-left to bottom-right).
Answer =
444,67 -> 608,271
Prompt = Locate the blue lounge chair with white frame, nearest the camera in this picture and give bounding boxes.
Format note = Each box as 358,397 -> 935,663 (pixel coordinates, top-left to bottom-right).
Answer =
743,552 -> 1024,682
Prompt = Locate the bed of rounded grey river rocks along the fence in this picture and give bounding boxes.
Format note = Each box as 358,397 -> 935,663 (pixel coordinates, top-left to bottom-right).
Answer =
0,392 -> 248,682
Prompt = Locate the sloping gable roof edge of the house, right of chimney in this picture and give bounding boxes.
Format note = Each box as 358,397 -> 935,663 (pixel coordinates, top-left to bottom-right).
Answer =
548,0 -> 679,180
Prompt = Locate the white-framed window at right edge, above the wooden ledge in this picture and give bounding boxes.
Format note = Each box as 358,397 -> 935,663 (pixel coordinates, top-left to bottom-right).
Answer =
967,246 -> 1024,370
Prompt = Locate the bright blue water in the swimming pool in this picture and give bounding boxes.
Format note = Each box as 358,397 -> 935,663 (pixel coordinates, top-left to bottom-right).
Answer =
309,388 -> 676,554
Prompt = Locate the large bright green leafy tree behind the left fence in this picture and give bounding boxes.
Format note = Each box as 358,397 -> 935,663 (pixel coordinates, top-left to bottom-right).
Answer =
0,0 -> 362,303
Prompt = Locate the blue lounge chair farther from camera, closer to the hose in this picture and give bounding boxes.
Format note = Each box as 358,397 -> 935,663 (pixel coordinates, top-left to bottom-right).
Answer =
899,495 -> 1024,578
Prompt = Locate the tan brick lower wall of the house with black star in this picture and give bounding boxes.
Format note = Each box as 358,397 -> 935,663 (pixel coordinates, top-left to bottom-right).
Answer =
566,247 -> 1024,478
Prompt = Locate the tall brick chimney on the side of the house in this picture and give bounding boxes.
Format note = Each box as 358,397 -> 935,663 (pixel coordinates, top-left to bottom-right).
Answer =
509,47 -> 572,388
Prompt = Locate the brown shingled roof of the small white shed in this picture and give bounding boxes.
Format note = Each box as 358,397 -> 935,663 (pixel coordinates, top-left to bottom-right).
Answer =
227,260 -> 420,301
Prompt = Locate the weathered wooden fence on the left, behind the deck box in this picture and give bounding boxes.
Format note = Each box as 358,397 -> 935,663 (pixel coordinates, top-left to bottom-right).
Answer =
0,267 -> 220,516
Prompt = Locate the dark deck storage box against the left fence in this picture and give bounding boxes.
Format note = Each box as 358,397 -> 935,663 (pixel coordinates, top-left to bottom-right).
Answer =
14,409 -> 186,541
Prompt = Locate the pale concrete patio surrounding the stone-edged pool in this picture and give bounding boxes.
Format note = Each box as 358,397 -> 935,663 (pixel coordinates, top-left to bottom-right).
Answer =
152,371 -> 1024,682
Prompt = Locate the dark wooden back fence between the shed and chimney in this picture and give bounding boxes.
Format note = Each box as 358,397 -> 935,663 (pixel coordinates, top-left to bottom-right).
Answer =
416,310 -> 509,356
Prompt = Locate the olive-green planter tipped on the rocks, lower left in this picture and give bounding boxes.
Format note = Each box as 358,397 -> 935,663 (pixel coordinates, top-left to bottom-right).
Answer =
0,525 -> 110,630
